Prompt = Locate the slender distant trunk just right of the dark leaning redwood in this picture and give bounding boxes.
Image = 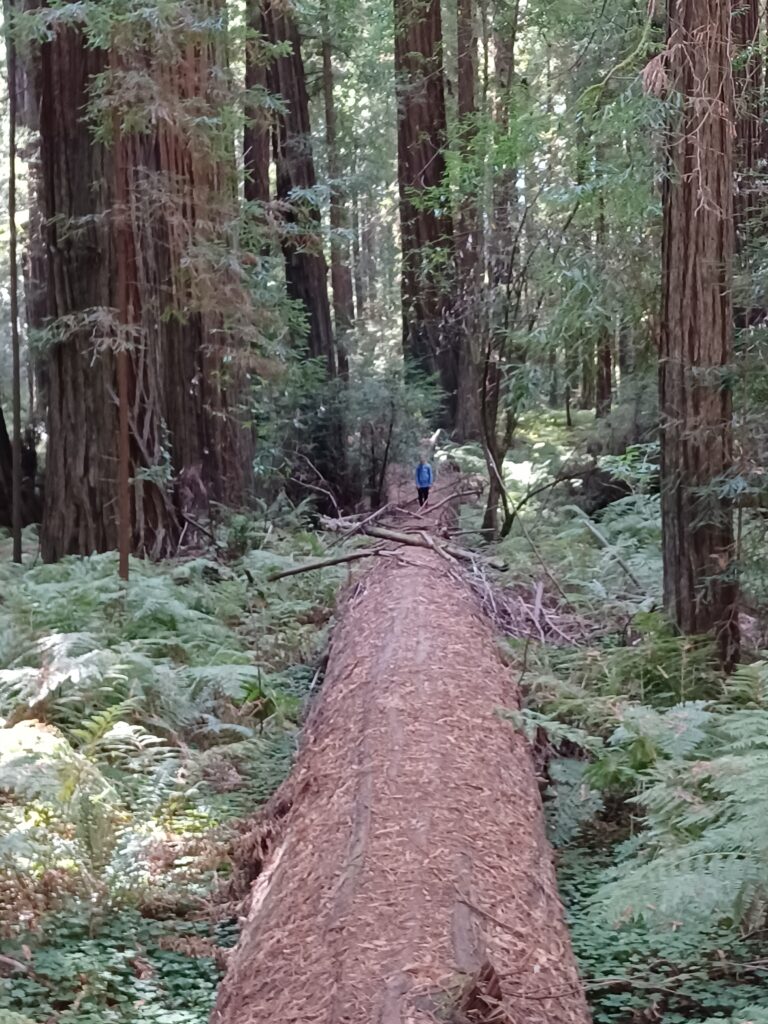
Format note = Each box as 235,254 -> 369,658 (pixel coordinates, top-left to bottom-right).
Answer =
323,0 -> 354,348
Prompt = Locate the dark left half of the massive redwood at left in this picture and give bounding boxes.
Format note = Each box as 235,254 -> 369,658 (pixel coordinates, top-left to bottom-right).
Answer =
40,28 -> 118,561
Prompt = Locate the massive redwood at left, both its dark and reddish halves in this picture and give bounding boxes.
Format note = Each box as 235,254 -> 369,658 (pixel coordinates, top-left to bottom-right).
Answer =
39,0 -> 251,559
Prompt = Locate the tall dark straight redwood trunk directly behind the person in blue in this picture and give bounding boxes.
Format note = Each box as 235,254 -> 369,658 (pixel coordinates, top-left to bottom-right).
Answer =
394,0 -> 459,426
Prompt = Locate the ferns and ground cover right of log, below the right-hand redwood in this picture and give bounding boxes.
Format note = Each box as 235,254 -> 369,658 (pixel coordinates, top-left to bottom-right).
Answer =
532,614 -> 768,1024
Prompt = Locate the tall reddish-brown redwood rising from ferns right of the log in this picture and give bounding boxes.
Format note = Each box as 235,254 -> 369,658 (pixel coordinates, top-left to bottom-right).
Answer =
659,0 -> 738,667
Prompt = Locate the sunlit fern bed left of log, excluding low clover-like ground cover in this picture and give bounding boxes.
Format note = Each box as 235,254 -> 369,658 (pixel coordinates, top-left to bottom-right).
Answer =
0,535 -> 343,922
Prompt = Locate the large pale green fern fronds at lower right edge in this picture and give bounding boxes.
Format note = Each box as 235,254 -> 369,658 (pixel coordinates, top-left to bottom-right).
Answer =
597,711 -> 768,933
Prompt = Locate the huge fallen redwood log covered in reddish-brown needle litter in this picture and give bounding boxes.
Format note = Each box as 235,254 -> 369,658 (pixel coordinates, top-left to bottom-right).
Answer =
212,551 -> 589,1024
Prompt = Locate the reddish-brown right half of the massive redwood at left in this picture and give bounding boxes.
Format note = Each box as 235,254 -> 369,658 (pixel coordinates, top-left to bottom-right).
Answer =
141,12 -> 253,506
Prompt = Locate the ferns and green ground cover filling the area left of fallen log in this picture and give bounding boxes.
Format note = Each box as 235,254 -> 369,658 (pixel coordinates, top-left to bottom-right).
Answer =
0,517 -> 346,1024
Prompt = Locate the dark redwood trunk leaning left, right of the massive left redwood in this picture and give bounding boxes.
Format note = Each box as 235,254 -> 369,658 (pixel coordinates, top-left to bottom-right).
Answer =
264,0 -> 337,377
